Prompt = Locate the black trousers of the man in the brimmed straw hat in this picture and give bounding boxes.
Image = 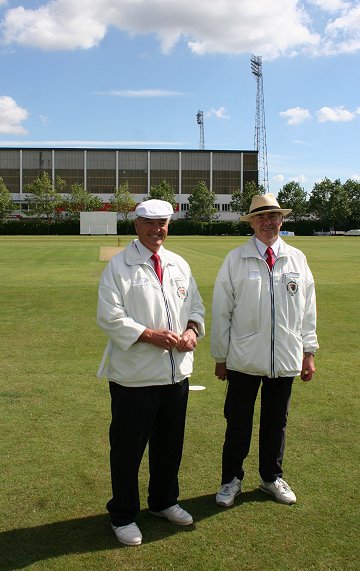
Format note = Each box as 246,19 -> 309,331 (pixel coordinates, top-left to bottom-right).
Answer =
222,371 -> 294,484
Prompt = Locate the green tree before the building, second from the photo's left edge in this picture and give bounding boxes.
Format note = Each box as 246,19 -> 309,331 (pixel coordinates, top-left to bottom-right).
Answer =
24,172 -> 66,223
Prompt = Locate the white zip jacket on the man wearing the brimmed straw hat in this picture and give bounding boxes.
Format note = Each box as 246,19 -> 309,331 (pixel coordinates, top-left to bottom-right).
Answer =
211,237 -> 318,378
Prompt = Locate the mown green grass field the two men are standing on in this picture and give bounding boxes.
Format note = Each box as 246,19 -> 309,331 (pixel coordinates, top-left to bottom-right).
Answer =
0,236 -> 360,571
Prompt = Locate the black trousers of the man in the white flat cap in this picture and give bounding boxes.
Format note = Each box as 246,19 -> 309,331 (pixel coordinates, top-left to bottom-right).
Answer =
107,379 -> 189,526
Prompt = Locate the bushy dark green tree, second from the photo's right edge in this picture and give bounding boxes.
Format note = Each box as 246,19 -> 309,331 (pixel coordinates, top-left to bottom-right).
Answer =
309,178 -> 350,232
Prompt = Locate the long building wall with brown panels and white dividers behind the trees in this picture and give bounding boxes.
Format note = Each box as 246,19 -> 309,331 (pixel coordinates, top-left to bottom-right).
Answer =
0,148 -> 258,218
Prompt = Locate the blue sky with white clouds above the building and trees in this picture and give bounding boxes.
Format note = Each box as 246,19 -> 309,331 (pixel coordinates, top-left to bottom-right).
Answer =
0,0 -> 360,194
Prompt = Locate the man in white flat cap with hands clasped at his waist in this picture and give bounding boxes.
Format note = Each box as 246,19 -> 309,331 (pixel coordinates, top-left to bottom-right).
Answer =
98,200 -> 205,545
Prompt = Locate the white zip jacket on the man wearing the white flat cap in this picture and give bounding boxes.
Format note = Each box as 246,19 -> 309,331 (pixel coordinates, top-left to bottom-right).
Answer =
97,240 -> 205,387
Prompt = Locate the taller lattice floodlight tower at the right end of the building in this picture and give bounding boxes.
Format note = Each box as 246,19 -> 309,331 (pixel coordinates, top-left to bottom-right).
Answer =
251,55 -> 269,192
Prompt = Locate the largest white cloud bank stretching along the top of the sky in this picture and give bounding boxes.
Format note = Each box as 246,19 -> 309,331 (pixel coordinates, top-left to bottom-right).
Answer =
2,0 -> 320,58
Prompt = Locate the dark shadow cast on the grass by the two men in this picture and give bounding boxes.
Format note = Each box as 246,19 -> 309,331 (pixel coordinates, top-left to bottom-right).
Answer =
0,490 -> 270,571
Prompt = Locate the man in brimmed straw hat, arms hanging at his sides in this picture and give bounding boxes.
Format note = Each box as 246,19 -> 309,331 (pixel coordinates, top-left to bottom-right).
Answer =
211,194 -> 318,507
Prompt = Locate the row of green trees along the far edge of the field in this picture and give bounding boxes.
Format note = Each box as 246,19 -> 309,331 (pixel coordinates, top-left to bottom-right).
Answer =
0,172 -> 360,231
